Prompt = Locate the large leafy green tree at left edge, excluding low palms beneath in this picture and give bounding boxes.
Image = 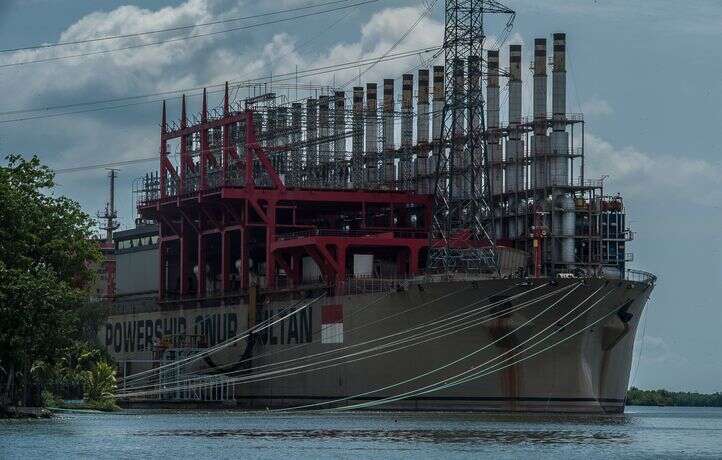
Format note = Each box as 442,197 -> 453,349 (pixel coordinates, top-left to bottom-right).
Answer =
0,155 -> 101,403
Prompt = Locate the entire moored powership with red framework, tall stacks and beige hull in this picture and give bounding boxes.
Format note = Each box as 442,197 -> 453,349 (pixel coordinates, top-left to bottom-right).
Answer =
101,1 -> 654,411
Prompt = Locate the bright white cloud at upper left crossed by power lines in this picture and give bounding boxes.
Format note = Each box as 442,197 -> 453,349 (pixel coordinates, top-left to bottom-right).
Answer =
2,0 -> 224,107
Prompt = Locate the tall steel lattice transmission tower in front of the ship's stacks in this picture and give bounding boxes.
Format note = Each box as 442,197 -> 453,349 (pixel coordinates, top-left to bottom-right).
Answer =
428,0 -> 515,272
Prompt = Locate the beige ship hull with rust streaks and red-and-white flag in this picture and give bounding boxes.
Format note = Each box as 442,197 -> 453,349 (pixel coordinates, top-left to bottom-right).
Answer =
105,279 -> 652,413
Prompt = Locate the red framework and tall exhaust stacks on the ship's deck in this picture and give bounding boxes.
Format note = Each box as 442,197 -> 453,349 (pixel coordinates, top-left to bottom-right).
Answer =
135,27 -> 631,303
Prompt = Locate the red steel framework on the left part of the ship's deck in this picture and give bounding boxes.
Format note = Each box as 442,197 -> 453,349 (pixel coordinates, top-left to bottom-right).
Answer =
139,84 -> 433,301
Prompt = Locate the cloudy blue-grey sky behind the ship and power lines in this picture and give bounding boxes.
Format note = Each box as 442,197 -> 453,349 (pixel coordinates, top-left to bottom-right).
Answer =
0,0 -> 722,392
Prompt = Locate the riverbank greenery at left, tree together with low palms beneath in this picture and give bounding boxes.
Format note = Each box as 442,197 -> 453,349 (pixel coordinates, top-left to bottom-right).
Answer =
0,155 -> 115,414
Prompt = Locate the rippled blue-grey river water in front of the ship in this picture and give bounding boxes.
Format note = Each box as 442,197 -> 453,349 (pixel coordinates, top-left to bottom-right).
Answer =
0,407 -> 722,460
